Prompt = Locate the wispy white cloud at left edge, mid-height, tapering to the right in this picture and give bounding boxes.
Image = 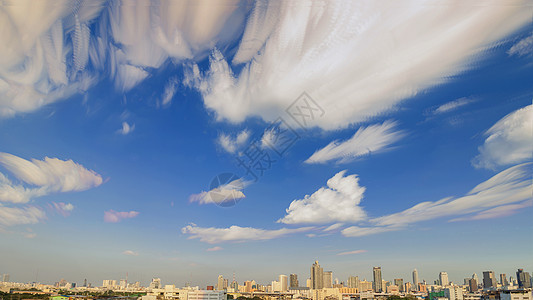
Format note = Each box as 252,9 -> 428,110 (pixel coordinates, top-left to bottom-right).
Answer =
0,152 -> 102,203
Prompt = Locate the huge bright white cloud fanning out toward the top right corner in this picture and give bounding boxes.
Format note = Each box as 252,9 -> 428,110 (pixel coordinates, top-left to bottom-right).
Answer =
187,0 -> 531,129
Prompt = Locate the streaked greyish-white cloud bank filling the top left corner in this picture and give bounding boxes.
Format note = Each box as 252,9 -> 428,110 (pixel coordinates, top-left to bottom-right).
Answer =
0,0 -> 248,117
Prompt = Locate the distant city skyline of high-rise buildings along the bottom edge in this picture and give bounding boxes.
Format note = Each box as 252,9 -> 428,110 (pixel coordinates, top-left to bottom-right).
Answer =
0,261 -> 533,300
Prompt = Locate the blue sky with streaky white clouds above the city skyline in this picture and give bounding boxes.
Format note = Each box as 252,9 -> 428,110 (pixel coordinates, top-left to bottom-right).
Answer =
0,1 -> 533,286
